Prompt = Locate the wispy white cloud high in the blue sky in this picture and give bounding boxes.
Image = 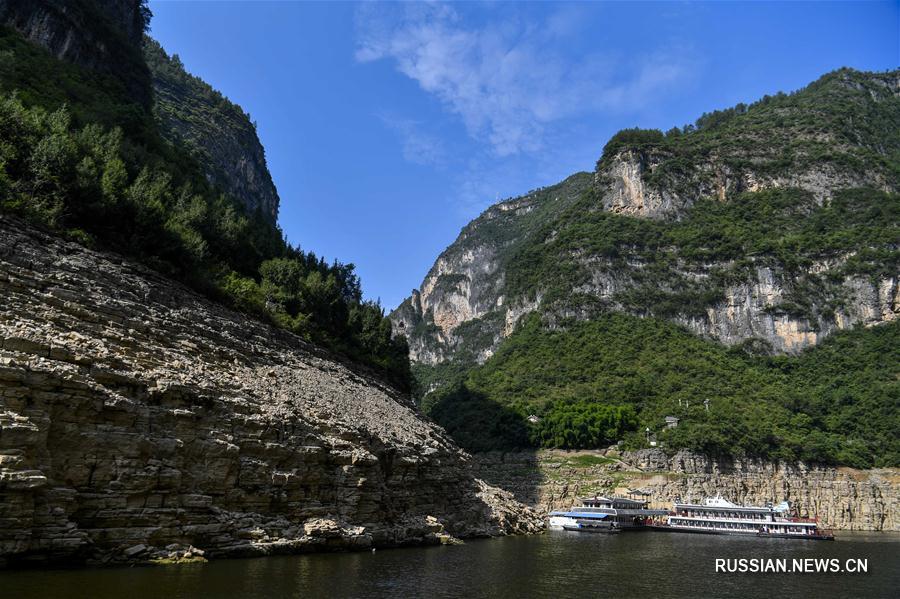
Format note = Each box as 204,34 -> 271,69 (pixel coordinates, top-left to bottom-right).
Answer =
356,3 -> 689,157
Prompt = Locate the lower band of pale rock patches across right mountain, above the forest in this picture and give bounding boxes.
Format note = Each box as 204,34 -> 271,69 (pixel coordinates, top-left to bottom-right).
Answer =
402,246 -> 900,365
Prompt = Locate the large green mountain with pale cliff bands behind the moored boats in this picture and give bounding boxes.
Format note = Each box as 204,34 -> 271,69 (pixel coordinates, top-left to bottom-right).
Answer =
391,69 -> 900,466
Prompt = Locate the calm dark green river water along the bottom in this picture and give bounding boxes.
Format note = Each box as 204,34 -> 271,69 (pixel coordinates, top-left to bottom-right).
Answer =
0,532 -> 900,599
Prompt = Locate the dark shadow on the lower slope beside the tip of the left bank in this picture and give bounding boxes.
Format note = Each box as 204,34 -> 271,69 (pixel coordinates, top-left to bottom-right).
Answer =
425,384 -> 543,505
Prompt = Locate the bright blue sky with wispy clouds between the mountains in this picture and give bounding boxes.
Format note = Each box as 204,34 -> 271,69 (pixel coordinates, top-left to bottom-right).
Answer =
150,1 -> 900,309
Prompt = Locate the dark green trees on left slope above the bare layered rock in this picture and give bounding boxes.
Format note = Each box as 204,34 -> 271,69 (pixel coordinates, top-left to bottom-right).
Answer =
0,24 -> 409,387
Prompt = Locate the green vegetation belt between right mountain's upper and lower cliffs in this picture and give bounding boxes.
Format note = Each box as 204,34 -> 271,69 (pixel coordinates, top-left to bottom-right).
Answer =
506,188 -> 900,326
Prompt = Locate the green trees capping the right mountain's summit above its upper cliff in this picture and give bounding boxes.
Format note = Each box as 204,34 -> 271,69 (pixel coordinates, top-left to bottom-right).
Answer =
598,69 -> 900,192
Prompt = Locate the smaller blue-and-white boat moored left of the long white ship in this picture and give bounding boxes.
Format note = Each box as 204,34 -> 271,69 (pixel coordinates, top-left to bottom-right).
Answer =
550,497 -> 669,532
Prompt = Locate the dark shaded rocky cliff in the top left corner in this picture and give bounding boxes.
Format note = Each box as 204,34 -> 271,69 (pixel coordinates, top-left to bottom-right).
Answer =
0,0 -> 152,107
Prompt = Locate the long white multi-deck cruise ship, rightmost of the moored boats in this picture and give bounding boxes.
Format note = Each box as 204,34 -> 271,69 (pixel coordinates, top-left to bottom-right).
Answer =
659,497 -> 834,540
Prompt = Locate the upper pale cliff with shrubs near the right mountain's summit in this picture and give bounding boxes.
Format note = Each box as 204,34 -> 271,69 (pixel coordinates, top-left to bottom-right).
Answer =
595,70 -> 900,218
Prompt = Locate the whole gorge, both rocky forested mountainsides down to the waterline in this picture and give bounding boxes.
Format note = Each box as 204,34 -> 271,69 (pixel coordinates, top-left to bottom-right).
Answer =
0,0 -> 900,568
